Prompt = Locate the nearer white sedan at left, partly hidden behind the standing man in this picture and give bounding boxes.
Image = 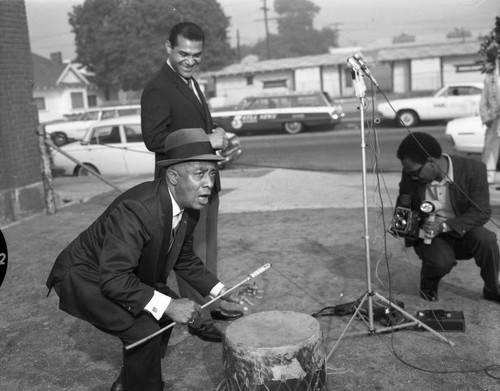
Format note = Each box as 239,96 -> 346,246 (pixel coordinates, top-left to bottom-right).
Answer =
52,115 -> 242,176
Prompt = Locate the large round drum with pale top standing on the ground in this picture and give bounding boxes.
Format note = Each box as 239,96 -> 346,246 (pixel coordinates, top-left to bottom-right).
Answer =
223,311 -> 326,391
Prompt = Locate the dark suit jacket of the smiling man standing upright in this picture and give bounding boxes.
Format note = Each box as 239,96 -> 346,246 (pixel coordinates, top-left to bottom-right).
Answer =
141,63 -> 220,192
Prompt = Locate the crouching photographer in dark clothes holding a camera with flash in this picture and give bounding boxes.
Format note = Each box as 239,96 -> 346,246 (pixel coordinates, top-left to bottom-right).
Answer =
390,132 -> 500,303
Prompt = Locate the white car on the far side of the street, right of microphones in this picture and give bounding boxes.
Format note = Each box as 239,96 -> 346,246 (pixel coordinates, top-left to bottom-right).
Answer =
377,83 -> 483,127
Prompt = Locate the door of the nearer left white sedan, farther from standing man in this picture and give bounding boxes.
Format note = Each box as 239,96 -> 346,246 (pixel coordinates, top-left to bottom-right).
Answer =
86,125 -> 128,176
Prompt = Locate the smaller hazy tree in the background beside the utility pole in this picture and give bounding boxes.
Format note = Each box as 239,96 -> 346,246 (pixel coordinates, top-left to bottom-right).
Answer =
252,0 -> 338,58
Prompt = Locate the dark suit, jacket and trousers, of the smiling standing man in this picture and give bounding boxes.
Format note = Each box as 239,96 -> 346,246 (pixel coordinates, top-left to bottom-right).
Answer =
141,63 -> 221,324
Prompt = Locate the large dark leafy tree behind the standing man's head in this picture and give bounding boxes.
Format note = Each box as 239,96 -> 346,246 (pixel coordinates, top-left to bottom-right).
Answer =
69,0 -> 233,91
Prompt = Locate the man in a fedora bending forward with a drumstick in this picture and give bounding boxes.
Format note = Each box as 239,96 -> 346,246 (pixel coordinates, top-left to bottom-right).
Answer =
46,129 -> 256,391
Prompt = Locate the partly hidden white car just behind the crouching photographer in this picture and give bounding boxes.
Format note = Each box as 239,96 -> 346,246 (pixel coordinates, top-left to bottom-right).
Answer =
445,116 -> 486,153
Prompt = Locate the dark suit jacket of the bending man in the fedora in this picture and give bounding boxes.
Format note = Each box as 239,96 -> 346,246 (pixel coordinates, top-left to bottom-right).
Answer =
46,179 -> 218,331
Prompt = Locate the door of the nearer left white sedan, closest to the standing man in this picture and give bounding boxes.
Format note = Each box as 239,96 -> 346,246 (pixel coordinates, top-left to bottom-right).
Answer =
123,124 -> 155,177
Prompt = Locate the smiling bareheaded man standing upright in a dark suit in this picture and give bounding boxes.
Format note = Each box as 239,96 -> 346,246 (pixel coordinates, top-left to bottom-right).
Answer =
141,22 -> 243,342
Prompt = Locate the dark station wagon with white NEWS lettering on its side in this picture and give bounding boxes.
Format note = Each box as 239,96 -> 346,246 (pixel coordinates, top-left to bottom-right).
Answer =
212,91 -> 345,134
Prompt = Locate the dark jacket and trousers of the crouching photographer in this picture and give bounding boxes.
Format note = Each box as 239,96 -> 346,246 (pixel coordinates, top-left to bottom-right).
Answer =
398,156 -> 500,295
